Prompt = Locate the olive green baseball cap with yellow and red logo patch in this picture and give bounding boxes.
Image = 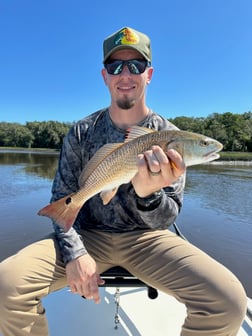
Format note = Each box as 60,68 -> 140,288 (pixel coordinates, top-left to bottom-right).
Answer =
103,27 -> 151,63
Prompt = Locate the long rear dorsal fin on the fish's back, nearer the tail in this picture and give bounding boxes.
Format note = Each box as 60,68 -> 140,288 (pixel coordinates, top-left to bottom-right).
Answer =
79,143 -> 124,187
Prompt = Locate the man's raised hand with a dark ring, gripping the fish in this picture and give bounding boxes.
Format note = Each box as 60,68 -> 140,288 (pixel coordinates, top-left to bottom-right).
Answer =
131,146 -> 186,197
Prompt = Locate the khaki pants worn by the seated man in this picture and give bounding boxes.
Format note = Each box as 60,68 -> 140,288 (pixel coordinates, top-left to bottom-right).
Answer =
0,230 -> 247,336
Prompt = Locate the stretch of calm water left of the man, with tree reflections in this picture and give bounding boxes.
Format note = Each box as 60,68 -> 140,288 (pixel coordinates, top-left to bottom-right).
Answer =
0,151 -> 58,260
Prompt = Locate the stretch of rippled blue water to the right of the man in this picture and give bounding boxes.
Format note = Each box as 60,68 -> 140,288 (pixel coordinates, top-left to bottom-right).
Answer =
177,165 -> 252,297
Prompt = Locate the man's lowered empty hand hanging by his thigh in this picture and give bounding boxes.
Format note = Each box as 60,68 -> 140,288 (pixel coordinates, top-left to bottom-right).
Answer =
66,254 -> 104,303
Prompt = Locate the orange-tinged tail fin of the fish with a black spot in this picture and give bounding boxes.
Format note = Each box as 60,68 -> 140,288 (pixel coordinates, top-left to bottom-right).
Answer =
38,194 -> 82,232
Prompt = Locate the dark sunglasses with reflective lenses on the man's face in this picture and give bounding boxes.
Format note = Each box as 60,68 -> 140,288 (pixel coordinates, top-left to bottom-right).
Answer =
104,59 -> 151,75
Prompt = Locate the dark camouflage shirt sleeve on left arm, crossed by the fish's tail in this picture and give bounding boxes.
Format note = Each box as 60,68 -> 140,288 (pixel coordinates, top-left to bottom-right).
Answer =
51,128 -> 87,264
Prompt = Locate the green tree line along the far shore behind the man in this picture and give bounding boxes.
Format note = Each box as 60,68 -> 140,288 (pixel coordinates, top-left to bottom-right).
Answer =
0,111 -> 252,152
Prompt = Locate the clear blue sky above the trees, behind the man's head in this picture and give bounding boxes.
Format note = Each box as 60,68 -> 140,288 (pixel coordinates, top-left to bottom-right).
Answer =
0,0 -> 252,123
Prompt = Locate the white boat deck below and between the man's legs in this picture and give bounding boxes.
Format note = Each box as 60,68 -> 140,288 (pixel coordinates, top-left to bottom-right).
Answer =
43,288 -> 252,336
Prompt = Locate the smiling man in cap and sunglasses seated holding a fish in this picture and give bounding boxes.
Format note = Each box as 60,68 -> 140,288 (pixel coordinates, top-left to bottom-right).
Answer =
0,27 -> 246,336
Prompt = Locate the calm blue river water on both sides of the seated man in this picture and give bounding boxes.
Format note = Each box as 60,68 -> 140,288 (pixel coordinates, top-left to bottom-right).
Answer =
0,151 -> 252,297
